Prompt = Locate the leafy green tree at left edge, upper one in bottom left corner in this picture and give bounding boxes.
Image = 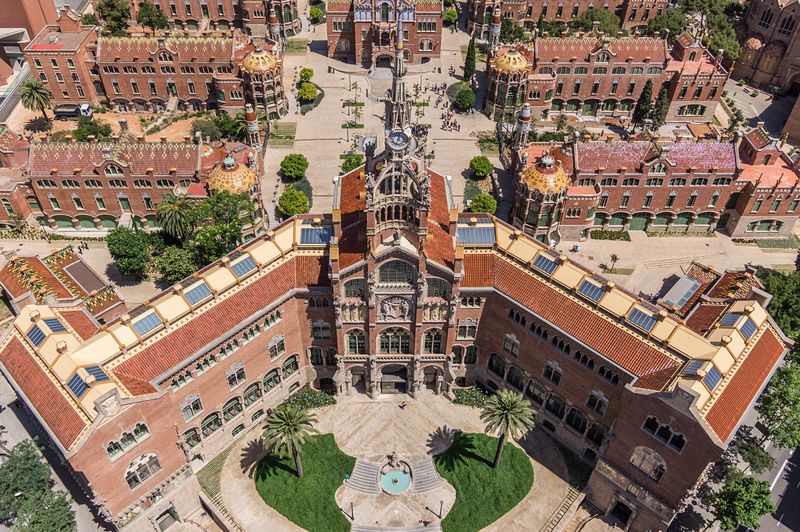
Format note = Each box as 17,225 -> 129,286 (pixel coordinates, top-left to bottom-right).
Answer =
0,440 -> 51,518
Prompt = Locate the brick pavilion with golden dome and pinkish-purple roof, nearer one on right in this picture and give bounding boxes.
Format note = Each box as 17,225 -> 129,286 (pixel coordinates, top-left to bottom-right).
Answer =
513,115 -> 800,242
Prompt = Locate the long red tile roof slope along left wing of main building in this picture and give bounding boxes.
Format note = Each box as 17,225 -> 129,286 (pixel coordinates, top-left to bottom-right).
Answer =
111,259 -> 296,393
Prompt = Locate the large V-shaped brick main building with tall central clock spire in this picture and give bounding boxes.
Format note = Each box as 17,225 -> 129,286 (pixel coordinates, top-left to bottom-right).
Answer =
0,35 -> 791,530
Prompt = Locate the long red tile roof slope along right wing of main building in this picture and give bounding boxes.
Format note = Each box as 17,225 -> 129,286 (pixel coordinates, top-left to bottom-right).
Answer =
495,257 -> 680,378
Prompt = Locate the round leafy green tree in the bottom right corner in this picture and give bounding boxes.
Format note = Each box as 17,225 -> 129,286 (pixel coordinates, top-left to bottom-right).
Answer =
712,471 -> 775,530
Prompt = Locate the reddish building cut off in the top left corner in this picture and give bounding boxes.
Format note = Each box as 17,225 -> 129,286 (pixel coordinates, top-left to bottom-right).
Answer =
0,0 -> 56,85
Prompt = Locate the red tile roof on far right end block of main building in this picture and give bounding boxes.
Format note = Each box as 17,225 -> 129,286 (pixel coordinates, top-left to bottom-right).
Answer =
706,328 -> 784,441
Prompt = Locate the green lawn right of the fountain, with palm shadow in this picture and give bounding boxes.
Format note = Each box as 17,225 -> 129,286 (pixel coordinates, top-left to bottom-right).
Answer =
433,432 -> 533,532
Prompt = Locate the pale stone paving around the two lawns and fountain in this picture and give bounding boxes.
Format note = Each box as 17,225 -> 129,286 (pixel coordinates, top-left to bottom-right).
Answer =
220,393 -> 569,531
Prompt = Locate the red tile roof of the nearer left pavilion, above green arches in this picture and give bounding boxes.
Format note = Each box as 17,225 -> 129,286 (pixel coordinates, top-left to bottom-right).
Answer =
30,142 -> 203,178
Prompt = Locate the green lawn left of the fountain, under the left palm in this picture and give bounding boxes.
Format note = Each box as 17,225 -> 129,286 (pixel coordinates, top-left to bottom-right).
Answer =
255,434 -> 356,531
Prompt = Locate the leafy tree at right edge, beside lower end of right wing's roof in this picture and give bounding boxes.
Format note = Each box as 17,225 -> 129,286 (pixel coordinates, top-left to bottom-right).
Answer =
756,362 -> 800,448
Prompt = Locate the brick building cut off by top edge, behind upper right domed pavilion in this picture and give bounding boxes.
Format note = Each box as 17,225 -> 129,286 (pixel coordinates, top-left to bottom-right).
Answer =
467,0 -> 669,37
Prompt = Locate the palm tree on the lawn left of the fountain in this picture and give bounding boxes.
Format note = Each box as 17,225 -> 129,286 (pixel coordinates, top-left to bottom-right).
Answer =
264,404 -> 319,478
